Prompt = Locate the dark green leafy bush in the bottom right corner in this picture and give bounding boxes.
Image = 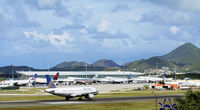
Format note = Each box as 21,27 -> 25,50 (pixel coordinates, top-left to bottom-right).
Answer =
176,89 -> 200,110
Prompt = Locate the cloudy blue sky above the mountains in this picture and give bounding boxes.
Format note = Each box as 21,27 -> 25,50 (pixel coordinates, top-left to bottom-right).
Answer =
0,0 -> 200,68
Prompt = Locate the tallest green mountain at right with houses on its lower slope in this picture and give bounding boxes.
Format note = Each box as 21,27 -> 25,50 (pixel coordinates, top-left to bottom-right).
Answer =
126,43 -> 200,73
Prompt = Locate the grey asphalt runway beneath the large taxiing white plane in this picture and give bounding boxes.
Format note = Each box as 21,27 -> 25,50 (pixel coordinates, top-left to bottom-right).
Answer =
0,95 -> 184,108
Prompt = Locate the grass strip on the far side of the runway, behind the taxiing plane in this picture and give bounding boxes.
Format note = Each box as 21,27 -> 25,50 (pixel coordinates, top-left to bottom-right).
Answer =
0,88 -> 188,101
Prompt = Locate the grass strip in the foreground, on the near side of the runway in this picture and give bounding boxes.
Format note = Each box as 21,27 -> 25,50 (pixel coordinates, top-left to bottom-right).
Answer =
0,101 -> 155,110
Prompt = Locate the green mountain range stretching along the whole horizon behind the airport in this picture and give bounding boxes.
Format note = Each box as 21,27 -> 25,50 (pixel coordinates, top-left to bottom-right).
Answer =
0,43 -> 200,75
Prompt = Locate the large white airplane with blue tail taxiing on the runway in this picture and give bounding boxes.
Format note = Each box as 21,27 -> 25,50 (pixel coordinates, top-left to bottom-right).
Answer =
44,75 -> 98,100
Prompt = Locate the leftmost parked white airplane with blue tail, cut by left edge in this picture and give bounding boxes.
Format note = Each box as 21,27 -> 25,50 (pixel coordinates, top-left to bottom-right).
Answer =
1,74 -> 37,86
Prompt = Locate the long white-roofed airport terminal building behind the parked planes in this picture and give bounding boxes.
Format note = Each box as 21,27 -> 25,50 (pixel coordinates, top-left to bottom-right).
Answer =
17,71 -> 144,79
